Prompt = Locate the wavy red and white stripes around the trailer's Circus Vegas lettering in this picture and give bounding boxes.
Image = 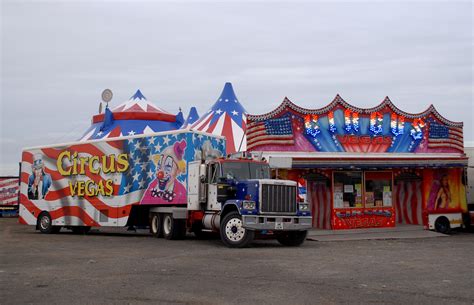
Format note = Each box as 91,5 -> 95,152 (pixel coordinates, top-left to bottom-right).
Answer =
20,140 -> 142,226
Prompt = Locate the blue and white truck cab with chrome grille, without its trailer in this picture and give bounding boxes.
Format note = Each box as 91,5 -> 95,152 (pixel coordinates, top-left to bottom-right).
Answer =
188,154 -> 312,247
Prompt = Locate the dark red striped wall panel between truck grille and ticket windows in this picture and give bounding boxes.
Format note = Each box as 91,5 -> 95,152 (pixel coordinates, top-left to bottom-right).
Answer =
306,181 -> 331,230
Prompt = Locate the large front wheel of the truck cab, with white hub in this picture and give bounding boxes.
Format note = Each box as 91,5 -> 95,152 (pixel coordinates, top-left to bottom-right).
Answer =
220,211 -> 255,248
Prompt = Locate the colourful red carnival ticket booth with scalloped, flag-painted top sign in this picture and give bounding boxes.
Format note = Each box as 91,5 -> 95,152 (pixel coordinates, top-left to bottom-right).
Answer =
247,95 -> 467,229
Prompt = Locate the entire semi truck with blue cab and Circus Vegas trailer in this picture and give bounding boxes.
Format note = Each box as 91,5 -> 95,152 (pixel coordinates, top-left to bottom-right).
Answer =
19,130 -> 311,247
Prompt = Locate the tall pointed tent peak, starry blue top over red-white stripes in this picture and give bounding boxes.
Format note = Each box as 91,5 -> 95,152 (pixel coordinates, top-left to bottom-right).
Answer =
191,83 -> 247,154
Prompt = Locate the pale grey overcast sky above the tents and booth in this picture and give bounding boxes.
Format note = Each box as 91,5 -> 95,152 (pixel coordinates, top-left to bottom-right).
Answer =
0,0 -> 474,175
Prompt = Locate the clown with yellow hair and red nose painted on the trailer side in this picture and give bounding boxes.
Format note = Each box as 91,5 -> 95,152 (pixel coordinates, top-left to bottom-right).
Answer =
141,140 -> 186,204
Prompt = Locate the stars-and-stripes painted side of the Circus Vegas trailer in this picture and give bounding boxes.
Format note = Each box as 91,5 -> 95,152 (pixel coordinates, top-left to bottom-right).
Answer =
20,131 -> 225,226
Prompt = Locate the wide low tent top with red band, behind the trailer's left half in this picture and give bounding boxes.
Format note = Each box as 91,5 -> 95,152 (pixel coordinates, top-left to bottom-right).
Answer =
79,90 -> 184,141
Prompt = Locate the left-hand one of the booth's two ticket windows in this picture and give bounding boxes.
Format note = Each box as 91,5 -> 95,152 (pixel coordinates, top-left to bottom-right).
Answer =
333,171 -> 363,209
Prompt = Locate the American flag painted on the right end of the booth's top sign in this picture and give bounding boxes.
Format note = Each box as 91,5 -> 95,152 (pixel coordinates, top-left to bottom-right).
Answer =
428,122 -> 464,151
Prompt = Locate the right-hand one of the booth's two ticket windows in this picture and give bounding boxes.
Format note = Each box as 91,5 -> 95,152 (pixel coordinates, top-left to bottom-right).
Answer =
365,172 -> 393,208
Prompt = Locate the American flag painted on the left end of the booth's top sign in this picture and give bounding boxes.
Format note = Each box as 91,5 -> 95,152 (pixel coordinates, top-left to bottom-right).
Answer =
247,115 -> 295,150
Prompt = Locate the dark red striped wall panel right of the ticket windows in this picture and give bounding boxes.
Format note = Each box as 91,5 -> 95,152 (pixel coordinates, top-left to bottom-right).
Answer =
394,180 -> 423,225
